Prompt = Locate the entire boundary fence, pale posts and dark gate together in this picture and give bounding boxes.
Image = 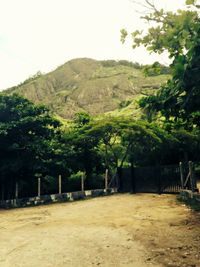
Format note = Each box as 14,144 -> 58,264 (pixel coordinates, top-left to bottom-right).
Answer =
0,162 -> 200,204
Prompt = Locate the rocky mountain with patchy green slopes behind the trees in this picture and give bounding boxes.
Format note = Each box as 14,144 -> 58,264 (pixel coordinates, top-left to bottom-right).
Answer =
3,58 -> 169,119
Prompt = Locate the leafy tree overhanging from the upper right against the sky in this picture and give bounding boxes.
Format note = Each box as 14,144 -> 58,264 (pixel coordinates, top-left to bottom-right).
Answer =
122,0 -> 200,129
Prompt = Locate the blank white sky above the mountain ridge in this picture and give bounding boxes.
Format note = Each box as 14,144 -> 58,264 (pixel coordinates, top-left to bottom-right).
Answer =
0,0 -> 184,90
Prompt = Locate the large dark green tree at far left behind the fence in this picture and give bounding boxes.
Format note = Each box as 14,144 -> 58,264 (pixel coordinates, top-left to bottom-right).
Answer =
0,94 -> 60,197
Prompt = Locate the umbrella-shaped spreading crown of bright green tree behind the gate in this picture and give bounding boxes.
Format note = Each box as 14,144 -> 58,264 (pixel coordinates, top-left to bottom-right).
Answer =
79,117 -> 166,171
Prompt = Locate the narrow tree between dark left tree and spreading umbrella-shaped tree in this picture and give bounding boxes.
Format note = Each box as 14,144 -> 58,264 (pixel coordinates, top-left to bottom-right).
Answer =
63,116 -> 103,187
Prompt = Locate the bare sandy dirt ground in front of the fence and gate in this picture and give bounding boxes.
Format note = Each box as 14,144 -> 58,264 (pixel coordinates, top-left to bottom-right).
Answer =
0,194 -> 200,267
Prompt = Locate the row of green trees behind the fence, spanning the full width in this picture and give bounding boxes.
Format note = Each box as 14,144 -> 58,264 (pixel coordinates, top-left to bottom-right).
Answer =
0,94 -> 200,199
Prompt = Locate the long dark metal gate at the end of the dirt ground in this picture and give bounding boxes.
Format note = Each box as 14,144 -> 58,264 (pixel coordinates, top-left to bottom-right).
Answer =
118,162 -> 197,194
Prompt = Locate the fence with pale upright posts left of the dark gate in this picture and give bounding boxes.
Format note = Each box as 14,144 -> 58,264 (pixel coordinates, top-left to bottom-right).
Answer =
0,169 -> 114,201
